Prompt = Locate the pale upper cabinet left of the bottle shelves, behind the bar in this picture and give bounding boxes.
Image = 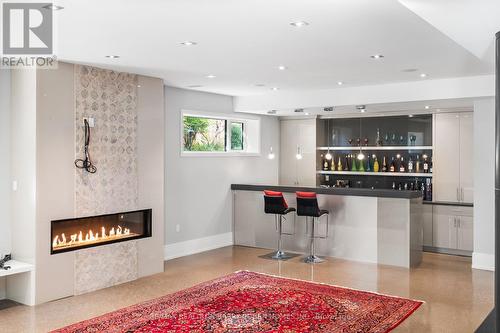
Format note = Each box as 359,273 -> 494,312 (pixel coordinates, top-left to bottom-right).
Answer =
280,119 -> 316,186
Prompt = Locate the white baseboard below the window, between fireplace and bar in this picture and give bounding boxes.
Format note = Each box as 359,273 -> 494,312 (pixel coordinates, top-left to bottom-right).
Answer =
163,232 -> 233,260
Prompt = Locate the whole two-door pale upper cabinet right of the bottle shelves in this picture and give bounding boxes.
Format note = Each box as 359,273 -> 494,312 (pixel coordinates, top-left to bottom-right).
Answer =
433,112 -> 474,203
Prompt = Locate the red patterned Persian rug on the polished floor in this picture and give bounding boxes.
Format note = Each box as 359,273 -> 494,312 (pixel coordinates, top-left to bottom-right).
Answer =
53,271 -> 422,333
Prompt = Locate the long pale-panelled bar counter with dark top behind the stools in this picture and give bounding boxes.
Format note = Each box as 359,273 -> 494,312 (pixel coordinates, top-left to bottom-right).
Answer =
231,184 -> 423,268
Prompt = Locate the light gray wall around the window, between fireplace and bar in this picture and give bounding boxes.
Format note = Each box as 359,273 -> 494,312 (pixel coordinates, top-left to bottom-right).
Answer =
165,87 -> 279,244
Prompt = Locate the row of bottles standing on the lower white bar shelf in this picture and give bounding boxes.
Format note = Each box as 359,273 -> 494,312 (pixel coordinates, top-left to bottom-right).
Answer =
321,153 -> 432,173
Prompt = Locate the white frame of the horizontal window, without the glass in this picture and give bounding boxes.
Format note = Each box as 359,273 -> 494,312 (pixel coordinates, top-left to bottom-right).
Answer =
180,110 -> 261,157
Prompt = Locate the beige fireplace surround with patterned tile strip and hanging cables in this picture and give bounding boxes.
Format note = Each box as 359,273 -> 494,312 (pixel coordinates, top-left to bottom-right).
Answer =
7,63 -> 164,305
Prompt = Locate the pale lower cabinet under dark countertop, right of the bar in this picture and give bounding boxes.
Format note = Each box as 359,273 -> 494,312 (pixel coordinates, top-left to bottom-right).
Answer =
430,205 -> 473,254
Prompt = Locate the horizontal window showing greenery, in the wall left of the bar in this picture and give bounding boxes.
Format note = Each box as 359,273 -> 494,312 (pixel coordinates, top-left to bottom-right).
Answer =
181,111 -> 260,156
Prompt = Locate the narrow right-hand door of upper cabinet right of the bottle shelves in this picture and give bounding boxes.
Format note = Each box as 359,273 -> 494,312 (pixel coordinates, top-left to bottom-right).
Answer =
460,112 -> 474,203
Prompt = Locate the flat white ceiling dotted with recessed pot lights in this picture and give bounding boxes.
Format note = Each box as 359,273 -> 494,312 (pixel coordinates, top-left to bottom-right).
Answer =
56,0 -> 500,96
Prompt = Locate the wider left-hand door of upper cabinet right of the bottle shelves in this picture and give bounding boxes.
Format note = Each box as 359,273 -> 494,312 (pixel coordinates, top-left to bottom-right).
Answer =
433,113 -> 460,202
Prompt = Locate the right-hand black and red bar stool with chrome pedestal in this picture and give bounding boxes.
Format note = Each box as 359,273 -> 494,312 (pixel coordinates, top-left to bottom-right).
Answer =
296,192 -> 329,263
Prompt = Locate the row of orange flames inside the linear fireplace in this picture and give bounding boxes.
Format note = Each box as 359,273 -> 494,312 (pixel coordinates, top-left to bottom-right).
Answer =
52,225 -> 133,250
